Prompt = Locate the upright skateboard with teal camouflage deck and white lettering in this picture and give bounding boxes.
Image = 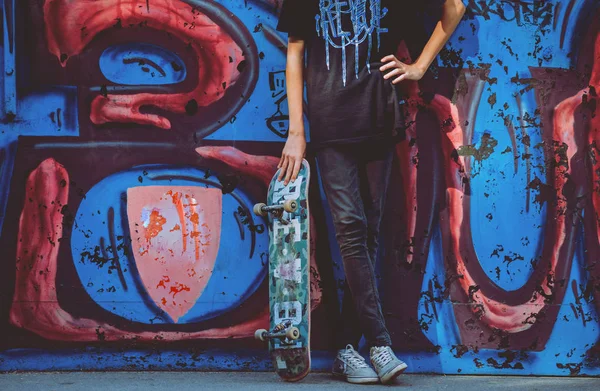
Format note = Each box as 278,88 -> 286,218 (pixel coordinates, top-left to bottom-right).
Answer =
254,160 -> 310,381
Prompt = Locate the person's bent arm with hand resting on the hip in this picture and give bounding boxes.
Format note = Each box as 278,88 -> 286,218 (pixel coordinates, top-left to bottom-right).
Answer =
379,0 -> 466,84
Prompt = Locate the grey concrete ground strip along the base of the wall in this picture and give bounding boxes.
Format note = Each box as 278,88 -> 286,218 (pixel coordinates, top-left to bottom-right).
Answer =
0,372 -> 600,391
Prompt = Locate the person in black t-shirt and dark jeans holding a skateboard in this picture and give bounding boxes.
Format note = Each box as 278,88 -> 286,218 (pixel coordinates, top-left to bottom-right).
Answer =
277,0 -> 465,383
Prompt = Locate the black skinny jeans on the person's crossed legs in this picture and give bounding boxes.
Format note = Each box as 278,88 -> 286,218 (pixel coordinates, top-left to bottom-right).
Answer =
317,142 -> 393,349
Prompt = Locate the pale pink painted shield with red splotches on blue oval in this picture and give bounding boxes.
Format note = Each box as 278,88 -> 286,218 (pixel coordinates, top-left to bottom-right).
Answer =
127,186 -> 223,322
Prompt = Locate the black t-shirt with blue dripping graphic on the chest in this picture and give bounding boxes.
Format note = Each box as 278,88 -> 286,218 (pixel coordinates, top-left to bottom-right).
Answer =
277,0 -> 445,147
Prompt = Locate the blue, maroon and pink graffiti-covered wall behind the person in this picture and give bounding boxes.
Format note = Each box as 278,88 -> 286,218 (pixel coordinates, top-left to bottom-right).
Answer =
0,0 -> 600,375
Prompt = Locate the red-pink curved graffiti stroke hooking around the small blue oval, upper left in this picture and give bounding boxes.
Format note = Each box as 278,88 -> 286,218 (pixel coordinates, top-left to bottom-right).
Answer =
44,0 -> 243,129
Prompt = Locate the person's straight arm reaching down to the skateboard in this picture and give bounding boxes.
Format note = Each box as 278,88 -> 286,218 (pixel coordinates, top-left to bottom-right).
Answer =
278,37 -> 306,185
